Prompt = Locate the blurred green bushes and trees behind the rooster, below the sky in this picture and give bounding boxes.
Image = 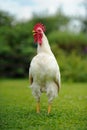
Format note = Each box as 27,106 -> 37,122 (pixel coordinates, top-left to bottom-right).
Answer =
0,6 -> 87,82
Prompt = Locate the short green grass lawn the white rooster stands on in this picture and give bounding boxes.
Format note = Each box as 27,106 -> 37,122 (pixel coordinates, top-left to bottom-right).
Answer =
0,80 -> 87,130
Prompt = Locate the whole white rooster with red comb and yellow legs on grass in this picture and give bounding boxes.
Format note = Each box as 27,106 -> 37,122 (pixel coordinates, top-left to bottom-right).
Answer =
29,23 -> 60,114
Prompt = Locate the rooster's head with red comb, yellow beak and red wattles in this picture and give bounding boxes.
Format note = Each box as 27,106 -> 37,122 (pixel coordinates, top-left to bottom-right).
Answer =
33,23 -> 45,45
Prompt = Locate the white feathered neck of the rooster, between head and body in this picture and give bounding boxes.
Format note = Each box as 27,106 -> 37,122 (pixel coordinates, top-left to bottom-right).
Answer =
37,34 -> 52,54
